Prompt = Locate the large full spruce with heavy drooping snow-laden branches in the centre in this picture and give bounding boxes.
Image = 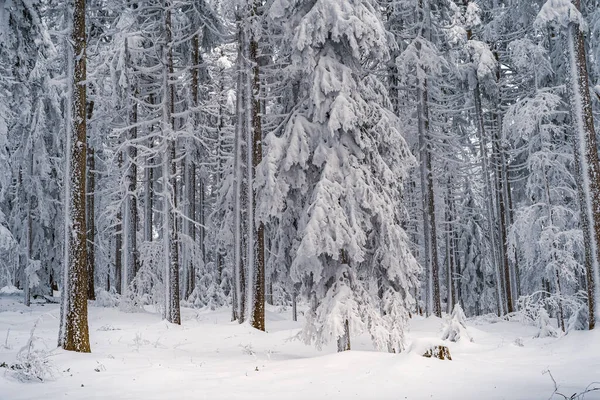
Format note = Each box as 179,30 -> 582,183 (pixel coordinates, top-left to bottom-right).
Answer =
257,0 -> 419,352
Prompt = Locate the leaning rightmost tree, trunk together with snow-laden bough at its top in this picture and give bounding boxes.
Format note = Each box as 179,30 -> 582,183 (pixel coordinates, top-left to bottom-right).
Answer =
535,0 -> 600,329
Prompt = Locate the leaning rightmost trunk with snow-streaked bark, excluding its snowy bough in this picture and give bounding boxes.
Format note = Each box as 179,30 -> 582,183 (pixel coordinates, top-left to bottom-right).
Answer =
567,0 -> 600,329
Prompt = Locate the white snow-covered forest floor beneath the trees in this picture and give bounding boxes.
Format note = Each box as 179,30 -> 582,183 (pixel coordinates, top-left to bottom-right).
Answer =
0,295 -> 600,400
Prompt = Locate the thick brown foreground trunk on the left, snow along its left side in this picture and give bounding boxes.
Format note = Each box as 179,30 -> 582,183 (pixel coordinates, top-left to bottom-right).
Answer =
59,0 -> 90,353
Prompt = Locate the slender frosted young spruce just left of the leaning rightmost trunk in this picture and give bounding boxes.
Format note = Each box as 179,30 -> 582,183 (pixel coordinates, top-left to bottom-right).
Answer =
504,90 -> 584,331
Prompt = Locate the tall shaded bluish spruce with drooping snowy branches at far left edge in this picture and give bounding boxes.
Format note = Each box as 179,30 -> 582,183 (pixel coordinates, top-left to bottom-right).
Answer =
0,1 -> 63,305
